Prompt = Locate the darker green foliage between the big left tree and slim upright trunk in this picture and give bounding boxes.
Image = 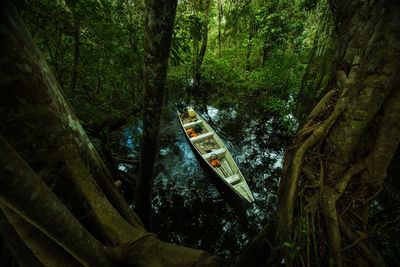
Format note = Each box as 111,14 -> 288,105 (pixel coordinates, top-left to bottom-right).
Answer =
19,0 -> 144,123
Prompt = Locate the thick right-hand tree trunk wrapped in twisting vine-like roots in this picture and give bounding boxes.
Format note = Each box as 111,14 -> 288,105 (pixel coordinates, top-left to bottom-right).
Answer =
276,0 -> 400,266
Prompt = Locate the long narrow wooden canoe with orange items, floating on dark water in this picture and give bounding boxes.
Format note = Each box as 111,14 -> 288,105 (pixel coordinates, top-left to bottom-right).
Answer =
177,111 -> 254,203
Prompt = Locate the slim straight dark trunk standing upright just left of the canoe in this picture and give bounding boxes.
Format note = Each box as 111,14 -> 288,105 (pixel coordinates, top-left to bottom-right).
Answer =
135,0 -> 177,229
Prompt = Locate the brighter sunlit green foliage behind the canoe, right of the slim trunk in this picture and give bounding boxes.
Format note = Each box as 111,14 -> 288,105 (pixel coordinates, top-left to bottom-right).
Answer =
168,1 -> 314,135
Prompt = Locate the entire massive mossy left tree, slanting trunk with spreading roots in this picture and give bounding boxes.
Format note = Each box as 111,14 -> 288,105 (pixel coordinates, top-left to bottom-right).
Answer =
0,2 -> 216,266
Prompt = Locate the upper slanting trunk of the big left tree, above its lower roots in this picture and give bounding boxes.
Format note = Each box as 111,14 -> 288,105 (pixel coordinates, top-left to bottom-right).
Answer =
0,2 -> 145,243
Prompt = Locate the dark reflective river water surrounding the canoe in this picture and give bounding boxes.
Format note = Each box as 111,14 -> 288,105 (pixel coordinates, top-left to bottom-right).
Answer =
125,107 -> 287,261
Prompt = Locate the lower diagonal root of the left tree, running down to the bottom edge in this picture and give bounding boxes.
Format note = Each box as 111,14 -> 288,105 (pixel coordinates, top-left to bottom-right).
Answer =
0,134 -> 115,266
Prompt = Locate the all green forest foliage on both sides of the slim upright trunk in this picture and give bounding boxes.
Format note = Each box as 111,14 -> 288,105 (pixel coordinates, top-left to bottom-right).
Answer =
19,0 -> 314,137
